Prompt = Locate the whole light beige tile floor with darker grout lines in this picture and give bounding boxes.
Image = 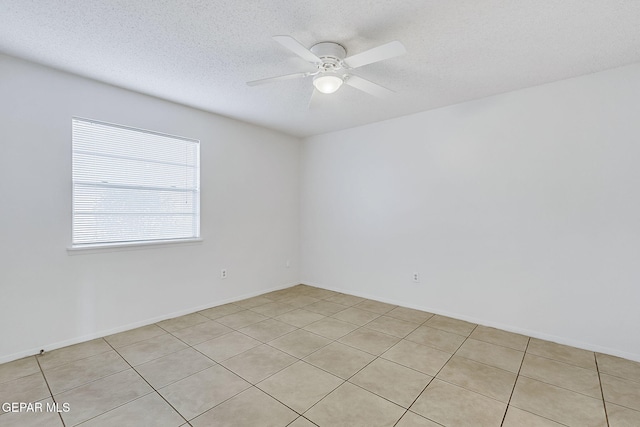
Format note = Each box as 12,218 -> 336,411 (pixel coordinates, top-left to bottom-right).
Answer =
0,285 -> 640,427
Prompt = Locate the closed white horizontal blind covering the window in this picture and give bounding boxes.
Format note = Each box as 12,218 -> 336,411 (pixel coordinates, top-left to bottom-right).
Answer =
72,118 -> 200,247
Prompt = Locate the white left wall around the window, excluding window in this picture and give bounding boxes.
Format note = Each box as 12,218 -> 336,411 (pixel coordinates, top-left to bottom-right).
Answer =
0,55 -> 300,362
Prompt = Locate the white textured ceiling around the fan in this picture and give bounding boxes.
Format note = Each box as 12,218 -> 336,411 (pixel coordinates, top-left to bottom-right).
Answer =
0,0 -> 640,136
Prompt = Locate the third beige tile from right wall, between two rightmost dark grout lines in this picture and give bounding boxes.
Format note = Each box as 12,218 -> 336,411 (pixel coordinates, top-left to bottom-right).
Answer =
510,376 -> 607,426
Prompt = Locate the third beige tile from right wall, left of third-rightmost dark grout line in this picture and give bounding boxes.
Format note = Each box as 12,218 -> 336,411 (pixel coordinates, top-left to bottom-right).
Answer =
380,340 -> 451,376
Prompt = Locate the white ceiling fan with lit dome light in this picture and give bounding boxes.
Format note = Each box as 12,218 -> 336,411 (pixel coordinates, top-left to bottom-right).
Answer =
247,36 -> 407,98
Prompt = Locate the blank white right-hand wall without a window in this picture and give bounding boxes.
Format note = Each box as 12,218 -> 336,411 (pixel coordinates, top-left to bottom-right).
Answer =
301,65 -> 640,360
